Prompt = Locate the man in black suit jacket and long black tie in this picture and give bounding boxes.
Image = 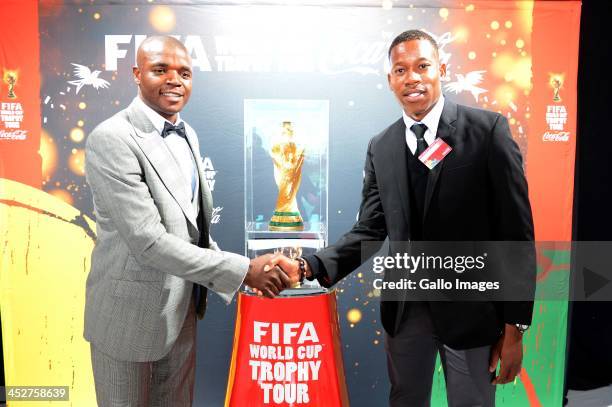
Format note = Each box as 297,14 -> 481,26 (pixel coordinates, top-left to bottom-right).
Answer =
277,30 -> 535,407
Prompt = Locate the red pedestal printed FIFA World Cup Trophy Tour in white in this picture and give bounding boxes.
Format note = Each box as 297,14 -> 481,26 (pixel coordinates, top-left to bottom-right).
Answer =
225,291 -> 349,407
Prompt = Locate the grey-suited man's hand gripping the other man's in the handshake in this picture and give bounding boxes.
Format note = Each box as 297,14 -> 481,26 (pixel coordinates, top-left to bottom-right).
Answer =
244,254 -> 291,298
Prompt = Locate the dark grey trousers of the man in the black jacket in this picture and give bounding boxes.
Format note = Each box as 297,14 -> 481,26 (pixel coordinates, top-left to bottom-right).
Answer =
385,302 -> 495,407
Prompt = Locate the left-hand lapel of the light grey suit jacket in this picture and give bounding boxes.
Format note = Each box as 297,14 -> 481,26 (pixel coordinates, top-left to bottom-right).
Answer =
128,102 -> 198,228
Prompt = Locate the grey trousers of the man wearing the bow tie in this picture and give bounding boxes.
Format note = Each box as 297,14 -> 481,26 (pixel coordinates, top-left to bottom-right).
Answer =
91,303 -> 196,407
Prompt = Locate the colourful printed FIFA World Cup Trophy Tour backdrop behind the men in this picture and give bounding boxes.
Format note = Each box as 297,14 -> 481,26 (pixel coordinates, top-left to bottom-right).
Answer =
0,0 -> 580,406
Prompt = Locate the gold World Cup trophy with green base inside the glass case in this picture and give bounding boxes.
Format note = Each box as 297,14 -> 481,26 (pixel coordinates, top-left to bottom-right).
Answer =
268,121 -> 304,231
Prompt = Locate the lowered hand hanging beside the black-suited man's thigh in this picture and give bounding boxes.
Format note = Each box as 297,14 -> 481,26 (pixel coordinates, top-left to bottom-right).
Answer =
489,324 -> 523,384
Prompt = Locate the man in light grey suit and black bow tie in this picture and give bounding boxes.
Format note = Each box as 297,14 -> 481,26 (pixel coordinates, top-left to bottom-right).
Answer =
84,37 -> 290,407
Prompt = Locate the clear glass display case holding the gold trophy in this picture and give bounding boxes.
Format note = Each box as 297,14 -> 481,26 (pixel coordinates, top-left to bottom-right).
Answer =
244,99 -> 329,290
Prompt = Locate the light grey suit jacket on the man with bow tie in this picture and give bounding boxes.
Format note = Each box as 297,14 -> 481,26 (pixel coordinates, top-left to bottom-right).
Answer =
84,99 -> 249,362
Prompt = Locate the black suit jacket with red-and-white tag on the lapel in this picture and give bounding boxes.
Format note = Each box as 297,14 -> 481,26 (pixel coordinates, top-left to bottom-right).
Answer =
307,99 -> 536,349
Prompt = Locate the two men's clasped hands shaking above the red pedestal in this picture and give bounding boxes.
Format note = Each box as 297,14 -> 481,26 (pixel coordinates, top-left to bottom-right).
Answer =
244,253 -> 310,298
